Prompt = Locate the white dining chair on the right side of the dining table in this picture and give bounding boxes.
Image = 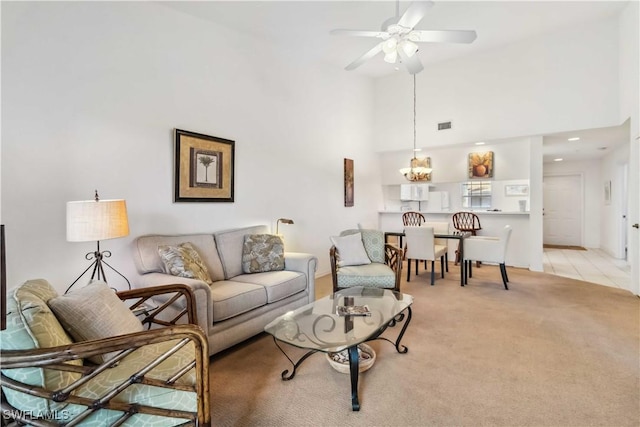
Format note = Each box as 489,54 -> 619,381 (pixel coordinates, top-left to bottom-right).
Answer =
462,225 -> 511,290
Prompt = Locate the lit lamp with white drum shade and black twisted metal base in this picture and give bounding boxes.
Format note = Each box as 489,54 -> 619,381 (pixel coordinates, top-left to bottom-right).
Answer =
65,190 -> 131,293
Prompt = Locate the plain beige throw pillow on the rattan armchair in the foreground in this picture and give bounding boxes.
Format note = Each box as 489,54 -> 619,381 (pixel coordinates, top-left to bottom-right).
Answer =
48,282 -> 144,363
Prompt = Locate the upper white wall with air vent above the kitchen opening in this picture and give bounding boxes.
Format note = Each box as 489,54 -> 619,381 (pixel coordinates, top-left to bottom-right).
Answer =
375,17 -> 622,151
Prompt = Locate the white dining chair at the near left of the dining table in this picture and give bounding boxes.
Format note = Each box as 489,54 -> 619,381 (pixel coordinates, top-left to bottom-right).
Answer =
404,226 -> 447,286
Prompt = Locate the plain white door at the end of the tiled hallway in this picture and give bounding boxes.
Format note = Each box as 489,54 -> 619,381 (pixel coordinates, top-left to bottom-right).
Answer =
542,175 -> 583,246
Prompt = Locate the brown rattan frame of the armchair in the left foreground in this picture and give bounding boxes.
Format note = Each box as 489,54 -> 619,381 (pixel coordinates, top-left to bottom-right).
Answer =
0,285 -> 211,426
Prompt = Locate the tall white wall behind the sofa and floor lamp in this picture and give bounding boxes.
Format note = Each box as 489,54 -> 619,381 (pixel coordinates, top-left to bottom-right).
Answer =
1,2 -> 381,290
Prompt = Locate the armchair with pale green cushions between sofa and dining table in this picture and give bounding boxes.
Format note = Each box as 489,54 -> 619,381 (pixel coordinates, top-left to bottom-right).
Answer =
329,229 -> 402,292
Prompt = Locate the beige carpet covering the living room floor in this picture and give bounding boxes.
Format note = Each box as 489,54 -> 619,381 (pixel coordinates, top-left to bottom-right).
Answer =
210,264 -> 640,426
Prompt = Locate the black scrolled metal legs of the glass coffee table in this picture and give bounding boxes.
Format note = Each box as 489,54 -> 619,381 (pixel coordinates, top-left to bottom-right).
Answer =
273,306 -> 411,411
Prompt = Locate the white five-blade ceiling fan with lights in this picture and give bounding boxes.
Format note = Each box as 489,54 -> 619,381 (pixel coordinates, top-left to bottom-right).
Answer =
331,0 -> 476,74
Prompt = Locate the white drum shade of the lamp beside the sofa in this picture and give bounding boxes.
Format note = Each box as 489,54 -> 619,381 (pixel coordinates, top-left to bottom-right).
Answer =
67,199 -> 129,242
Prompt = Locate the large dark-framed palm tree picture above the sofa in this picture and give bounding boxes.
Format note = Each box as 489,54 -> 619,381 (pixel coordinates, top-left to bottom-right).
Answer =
174,129 -> 235,202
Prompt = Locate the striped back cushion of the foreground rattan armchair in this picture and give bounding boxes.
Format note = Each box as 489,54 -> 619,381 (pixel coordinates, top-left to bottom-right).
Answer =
0,279 -> 82,412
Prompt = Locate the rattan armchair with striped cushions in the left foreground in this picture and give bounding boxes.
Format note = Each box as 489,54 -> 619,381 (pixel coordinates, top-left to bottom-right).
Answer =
0,280 -> 211,427
